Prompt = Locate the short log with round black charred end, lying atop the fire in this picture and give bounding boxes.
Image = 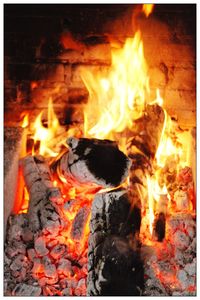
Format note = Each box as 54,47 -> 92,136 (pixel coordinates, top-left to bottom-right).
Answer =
52,138 -> 130,187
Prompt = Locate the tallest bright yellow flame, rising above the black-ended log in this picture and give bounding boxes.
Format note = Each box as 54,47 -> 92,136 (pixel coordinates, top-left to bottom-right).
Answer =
81,31 -> 149,139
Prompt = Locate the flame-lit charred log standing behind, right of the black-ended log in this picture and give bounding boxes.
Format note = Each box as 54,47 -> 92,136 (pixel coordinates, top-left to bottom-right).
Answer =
127,104 -> 165,233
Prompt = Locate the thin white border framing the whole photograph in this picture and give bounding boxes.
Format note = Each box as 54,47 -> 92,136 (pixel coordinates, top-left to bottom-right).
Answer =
0,0 -> 200,300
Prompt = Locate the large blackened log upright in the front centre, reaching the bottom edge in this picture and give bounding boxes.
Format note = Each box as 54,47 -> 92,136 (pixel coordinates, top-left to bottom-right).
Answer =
87,189 -> 143,296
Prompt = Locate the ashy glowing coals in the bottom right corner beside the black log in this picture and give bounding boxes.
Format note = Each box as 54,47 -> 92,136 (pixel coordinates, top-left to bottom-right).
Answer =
142,214 -> 196,296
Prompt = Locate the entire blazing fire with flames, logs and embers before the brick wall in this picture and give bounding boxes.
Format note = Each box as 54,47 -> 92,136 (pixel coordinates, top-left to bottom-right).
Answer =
4,4 -> 196,296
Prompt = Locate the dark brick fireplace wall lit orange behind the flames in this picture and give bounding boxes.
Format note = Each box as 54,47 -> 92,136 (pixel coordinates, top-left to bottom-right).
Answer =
4,4 -> 196,126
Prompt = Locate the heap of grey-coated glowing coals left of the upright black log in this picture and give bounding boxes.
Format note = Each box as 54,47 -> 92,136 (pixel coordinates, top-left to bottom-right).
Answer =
4,209 -> 87,296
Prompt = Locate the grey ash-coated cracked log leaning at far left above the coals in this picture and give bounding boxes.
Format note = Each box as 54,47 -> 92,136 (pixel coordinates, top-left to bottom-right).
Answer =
21,156 -> 62,232
